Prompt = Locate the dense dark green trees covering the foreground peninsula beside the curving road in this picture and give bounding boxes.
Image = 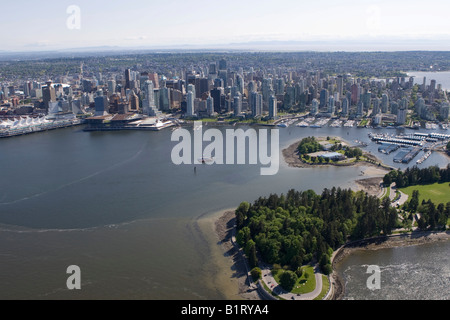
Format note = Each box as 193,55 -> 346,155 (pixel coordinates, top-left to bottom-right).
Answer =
236,187 -> 397,272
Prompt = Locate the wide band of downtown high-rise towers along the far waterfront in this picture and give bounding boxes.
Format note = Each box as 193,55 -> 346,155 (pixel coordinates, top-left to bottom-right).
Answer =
0,56 -> 449,126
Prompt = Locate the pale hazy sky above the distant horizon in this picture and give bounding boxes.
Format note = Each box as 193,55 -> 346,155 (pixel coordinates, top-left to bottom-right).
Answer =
0,0 -> 450,51
